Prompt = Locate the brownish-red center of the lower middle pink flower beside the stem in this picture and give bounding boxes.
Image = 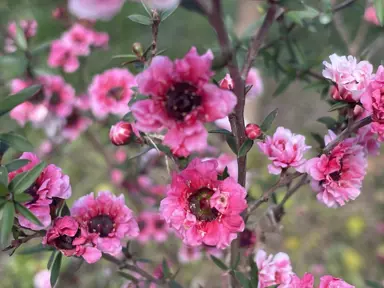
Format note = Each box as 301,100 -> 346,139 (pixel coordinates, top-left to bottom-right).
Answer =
188,188 -> 219,222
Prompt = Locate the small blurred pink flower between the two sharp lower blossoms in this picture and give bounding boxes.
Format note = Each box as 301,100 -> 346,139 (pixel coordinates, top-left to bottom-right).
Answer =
137,211 -> 168,243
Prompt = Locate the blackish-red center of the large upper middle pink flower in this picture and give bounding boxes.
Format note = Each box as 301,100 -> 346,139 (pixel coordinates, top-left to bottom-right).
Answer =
166,83 -> 201,121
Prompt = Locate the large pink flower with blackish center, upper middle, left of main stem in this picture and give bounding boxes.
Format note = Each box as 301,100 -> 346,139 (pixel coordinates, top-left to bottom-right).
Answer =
132,47 -> 237,157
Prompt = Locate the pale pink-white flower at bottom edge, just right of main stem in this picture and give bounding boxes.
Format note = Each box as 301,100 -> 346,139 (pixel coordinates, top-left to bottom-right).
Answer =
255,250 -> 293,288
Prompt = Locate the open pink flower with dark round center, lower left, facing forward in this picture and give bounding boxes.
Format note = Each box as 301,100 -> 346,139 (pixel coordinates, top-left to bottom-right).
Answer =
71,191 -> 139,255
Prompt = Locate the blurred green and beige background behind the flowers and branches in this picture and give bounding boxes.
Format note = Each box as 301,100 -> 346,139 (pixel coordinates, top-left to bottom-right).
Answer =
0,0 -> 384,287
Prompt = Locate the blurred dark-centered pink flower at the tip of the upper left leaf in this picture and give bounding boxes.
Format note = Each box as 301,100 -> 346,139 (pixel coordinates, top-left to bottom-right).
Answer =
40,75 -> 75,117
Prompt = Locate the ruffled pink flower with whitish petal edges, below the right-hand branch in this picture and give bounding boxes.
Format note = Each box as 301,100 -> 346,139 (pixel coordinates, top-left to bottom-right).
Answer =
306,131 -> 367,207
